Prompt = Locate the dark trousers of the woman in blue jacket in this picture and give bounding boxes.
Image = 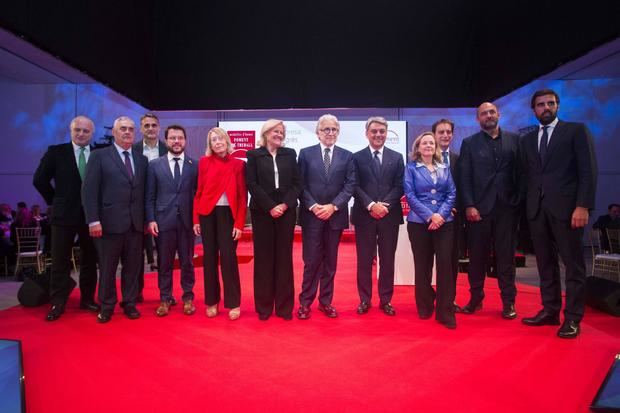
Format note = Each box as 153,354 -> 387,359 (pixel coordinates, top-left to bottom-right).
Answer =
407,222 -> 456,321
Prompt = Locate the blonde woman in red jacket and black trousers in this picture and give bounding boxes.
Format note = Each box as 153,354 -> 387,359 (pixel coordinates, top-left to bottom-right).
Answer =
194,128 -> 248,320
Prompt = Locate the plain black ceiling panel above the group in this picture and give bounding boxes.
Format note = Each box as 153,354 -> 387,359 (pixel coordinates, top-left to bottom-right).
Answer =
0,0 -> 620,110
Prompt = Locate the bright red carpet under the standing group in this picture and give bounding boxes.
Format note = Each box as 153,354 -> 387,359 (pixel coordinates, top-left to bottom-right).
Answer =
0,243 -> 620,413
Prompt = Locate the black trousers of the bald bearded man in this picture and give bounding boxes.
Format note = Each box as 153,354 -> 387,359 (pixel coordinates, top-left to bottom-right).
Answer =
467,204 -> 517,305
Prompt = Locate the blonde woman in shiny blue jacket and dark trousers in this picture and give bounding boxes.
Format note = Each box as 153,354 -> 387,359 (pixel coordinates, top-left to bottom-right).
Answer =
405,132 -> 456,329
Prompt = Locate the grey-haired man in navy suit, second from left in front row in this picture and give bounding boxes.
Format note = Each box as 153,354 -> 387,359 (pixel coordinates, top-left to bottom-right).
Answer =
82,116 -> 148,323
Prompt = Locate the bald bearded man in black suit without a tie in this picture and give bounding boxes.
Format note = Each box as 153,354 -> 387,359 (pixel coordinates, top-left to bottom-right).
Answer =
459,102 -> 520,320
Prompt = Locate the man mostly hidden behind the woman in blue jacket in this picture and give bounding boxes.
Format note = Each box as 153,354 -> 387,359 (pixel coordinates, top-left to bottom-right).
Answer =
431,119 -> 467,313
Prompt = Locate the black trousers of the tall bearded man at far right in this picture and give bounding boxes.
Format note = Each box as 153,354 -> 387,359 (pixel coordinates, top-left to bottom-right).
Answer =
529,203 -> 586,321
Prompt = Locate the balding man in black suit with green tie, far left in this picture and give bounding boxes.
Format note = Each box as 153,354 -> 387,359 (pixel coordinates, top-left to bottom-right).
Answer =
32,116 -> 100,321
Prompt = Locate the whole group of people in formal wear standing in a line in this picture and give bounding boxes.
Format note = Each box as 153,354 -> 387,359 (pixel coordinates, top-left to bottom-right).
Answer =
34,89 -> 597,337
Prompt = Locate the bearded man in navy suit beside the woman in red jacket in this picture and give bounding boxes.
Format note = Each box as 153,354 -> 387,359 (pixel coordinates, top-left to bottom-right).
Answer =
146,125 -> 198,317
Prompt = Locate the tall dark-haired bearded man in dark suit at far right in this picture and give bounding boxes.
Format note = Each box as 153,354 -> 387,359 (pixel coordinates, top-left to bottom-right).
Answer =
521,89 -> 598,338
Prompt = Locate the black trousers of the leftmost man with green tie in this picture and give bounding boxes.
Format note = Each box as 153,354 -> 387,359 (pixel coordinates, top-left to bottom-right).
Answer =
50,224 -> 97,305
